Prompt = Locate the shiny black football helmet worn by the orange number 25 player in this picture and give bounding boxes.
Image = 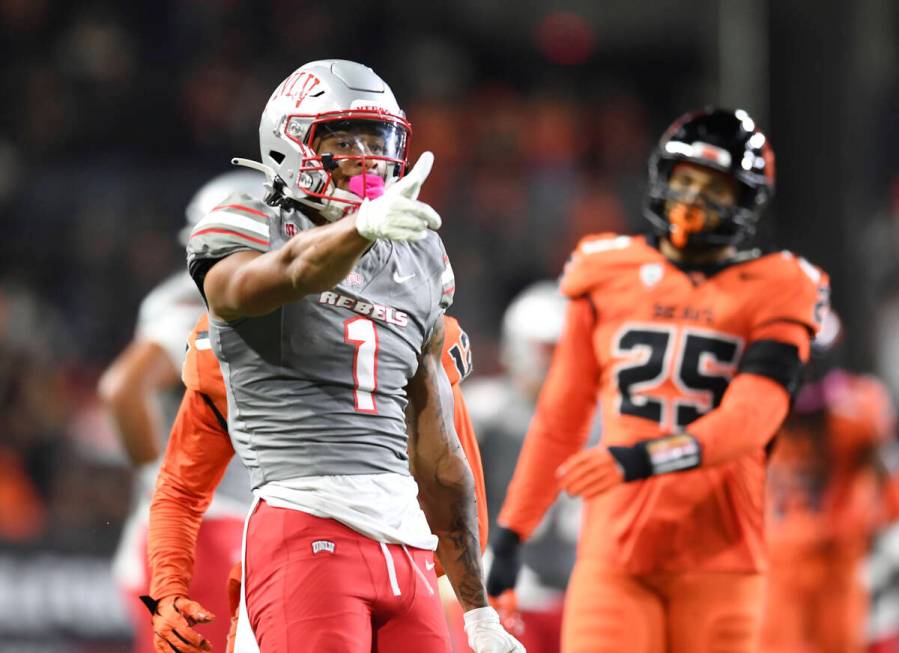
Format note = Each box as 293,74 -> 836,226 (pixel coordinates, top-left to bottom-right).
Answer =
644,108 -> 774,247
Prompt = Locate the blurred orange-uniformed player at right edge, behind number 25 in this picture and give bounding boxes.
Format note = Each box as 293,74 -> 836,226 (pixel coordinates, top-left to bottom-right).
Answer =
762,312 -> 895,653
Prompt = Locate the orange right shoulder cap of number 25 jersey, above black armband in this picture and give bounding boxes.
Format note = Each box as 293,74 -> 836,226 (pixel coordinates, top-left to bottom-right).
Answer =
746,250 -> 830,334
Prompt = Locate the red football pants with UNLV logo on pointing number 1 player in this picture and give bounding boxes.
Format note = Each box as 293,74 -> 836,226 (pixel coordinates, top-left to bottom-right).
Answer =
245,501 -> 450,653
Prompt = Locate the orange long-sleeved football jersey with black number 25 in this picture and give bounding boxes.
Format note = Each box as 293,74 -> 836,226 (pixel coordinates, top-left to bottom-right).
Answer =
500,234 -> 828,573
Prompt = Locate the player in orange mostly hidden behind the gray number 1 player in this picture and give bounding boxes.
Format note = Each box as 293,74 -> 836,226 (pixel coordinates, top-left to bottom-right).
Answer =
146,314 -> 487,653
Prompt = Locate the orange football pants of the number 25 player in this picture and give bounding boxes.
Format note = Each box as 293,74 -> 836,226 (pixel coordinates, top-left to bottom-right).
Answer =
561,559 -> 765,653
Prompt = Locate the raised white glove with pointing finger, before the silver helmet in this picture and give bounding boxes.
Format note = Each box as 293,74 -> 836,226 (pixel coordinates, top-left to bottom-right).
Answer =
356,152 -> 441,240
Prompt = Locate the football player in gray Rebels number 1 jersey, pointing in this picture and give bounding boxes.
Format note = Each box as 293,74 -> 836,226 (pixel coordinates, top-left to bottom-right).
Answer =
179,60 -> 524,653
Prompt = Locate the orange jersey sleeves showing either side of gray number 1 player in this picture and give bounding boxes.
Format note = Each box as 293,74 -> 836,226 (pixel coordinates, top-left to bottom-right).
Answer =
148,313 -> 488,599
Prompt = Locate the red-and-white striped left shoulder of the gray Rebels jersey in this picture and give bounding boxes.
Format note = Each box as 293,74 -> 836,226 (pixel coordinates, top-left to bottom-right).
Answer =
187,193 -> 277,264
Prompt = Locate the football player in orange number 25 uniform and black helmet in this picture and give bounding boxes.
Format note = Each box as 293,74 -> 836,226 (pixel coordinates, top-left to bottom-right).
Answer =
487,109 -> 828,653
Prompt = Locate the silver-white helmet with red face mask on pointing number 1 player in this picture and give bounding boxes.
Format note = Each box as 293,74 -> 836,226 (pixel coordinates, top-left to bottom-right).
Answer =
246,59 -> 412,221
